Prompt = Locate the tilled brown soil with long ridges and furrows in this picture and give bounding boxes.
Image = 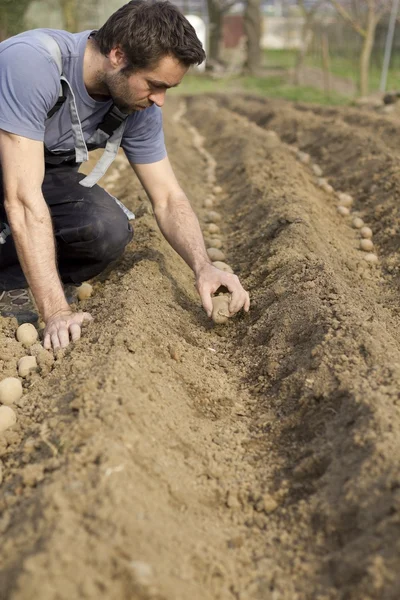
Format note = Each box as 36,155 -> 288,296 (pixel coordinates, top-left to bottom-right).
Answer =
0,96 -> 400,600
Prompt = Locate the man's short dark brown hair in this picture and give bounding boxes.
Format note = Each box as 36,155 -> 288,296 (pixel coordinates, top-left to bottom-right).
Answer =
94,0 -> 205,72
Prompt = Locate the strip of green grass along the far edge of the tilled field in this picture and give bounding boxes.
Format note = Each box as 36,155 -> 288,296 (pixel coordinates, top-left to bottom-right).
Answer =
168,73 -> 349,104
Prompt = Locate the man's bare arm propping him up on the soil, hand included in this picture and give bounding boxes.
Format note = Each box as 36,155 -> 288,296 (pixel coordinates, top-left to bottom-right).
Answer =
0,130 -> 91,348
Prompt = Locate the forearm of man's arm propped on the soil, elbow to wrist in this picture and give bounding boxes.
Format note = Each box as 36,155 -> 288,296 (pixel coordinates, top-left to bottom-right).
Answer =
5,195 -> 68,321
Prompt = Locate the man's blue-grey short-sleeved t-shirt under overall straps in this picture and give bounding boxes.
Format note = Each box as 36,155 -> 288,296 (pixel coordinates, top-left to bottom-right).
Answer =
0,29 -> 166,164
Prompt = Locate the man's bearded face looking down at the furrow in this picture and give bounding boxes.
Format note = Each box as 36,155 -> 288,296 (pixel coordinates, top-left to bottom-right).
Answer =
104,56 -> 188,114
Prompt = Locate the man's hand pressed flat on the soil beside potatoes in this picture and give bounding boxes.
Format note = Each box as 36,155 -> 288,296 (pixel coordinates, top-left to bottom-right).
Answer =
43,310 -> 92,350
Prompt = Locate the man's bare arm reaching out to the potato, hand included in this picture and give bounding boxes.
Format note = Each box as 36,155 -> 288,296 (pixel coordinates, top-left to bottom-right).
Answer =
131,158 -> 250,316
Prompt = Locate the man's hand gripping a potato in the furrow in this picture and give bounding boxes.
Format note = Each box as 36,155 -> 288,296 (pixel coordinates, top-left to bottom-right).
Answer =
196,264 -> 250,317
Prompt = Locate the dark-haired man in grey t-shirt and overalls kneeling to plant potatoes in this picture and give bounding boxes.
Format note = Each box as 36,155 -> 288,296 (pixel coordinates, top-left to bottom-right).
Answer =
0,0 -> 249,349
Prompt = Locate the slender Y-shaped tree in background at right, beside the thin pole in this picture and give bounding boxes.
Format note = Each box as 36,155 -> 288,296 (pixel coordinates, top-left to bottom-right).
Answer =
330,0 -> 392,96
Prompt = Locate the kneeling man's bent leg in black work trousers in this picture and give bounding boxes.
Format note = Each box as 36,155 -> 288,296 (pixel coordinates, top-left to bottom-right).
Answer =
0,166 -> 133,292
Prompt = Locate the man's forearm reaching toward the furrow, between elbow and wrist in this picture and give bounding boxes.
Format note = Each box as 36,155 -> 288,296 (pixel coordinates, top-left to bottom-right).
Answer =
155,194 -> 211,274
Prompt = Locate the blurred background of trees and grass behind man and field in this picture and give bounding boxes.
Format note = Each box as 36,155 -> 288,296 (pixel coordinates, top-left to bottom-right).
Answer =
0,0 -> 400,106
